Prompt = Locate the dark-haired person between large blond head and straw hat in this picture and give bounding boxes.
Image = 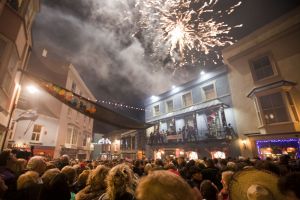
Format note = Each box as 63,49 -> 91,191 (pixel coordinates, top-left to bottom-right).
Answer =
200,180 -> 218,200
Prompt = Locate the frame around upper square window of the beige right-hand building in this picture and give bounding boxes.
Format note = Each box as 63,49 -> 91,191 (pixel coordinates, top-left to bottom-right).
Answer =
248,52 -> 278,82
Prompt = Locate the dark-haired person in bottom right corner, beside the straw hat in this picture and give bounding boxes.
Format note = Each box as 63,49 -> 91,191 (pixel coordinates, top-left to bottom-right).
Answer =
278,172 -> 300,200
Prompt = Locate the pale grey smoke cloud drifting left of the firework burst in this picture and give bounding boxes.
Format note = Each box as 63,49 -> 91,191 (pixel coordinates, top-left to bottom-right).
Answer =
34,0 -> 180,103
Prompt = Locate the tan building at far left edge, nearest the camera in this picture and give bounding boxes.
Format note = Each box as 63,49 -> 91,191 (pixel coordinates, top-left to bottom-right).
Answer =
0,0 -> 40,147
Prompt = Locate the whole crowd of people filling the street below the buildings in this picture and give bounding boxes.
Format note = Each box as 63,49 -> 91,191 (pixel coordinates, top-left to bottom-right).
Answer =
0,150 -> 300,200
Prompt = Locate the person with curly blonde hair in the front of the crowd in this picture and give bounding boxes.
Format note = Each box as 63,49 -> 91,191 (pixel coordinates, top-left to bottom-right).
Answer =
99,164 -> 134,200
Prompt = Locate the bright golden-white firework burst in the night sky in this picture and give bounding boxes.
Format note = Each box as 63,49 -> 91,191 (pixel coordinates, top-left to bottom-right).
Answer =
136,0 -> 242,68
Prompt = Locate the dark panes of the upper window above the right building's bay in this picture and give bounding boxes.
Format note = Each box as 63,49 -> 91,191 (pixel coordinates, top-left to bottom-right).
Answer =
251,56 -> 274,81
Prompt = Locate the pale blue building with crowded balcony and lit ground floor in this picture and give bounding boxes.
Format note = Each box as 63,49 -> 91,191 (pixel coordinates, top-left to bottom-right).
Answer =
145,66 -> 239,158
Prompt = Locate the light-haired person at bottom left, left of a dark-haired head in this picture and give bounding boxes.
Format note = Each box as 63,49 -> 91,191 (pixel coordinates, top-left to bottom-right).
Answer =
17,171 -> 43,200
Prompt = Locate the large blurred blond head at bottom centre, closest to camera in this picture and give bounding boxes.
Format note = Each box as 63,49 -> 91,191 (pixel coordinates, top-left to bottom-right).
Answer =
136,170 -> 195,200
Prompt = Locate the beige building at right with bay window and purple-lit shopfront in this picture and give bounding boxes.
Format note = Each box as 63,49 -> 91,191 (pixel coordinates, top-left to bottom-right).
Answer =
223,8 -> 300,158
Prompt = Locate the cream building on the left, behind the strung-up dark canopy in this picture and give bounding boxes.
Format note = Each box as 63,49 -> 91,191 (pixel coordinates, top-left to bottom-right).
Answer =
7,64 -> 95,160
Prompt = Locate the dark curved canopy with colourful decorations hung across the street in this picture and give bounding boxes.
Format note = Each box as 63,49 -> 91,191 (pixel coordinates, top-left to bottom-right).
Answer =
23,71 -> 152,129
